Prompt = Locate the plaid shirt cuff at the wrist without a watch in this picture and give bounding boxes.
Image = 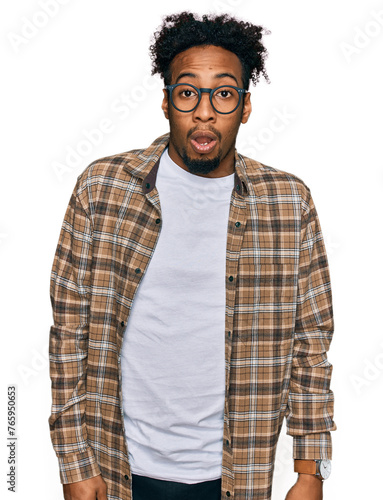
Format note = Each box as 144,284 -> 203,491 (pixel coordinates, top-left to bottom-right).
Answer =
58,447 -> 101,484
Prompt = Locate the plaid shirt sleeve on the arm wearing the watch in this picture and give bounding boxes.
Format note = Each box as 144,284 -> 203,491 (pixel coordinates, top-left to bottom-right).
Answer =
286,188 -> 336,460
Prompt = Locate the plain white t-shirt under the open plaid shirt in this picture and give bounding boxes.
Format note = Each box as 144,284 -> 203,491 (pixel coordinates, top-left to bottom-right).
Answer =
121,150 -> 234,483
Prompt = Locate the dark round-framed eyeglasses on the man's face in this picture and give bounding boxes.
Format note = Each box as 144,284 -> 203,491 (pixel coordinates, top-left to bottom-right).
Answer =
165,83 -> 248,115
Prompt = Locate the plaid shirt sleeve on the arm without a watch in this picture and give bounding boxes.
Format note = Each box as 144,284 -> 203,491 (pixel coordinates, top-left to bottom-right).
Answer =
49,185 -> 100,484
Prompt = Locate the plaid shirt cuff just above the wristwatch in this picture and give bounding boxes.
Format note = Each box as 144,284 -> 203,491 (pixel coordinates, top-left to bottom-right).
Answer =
293,432 -> 332,460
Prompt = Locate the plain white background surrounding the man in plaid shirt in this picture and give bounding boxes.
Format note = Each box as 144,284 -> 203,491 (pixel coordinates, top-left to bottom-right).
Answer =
0,0 -> 383,500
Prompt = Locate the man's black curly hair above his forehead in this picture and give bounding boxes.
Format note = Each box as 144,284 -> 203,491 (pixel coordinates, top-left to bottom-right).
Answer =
150,12 -> 270,89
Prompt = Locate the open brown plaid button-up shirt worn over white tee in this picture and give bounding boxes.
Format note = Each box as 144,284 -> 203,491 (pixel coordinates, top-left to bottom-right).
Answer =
49,134 -> 336,500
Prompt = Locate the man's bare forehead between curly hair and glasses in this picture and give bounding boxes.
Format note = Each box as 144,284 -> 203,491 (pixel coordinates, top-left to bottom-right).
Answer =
170,45 -> 242,83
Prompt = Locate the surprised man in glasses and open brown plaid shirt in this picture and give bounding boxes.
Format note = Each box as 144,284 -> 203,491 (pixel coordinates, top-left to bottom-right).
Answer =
49,12 -> 335,500
